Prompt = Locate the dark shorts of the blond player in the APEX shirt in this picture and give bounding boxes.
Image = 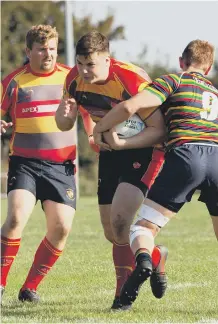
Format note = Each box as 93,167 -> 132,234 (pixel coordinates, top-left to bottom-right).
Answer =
7,156 -> 76,209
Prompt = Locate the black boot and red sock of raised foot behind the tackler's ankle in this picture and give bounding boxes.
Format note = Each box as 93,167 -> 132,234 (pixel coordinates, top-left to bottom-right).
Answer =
150,245 -> 168,298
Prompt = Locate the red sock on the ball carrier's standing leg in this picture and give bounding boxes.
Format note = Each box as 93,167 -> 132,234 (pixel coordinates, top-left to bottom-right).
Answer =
113,242 -> 135,297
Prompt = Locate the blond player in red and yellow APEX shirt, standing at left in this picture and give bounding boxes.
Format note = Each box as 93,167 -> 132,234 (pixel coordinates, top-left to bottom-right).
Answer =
1,25 -> 93,301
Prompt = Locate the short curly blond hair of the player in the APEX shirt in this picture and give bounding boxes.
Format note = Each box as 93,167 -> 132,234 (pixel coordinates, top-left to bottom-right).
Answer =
26,25 -> 58,49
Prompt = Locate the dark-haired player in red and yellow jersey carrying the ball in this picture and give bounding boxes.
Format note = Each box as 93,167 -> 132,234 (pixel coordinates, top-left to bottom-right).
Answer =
56,31 -> 167,309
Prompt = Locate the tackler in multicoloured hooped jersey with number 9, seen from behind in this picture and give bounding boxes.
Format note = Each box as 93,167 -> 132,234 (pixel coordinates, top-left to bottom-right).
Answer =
95,40 -> 218,305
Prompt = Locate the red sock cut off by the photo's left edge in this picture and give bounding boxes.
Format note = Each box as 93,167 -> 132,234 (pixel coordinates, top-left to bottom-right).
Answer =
1,236 -> 21,287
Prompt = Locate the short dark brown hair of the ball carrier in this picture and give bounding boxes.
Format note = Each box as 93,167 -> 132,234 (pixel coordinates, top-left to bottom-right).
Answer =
76,30 -> 109,56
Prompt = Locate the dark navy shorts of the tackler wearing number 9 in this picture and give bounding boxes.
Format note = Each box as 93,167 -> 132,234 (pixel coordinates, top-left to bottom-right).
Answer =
147,143 -> 218,216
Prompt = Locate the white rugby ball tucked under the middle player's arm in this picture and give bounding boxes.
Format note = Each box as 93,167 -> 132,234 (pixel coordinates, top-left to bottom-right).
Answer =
115,114 -> 145,138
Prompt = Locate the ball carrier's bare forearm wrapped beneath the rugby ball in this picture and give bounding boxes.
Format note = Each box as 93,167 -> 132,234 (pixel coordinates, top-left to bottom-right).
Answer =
116,127 -> 166,150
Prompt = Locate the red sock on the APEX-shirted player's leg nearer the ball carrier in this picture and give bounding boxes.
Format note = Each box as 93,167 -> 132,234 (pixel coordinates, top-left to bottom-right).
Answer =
21,237 -> 62,290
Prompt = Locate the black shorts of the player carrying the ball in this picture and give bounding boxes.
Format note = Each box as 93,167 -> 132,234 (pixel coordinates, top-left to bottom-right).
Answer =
98,148 -> 153,205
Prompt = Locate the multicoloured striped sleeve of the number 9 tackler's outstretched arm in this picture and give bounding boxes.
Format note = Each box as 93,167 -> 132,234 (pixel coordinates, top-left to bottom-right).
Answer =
144,74 -> 178,103
